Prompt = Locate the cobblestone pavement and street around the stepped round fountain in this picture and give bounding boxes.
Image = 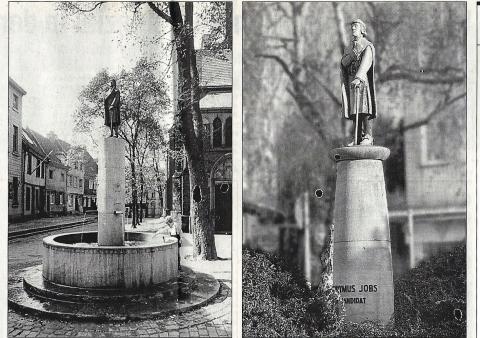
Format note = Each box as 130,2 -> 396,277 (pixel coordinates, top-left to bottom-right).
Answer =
8,219 -> 232,337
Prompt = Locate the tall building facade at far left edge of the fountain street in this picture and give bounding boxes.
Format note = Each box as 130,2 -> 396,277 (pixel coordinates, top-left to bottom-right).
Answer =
8,77 -> 27,220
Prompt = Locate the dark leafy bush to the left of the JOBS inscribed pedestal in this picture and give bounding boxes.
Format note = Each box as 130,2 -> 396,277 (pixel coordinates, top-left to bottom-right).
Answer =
242,250 -> 342,337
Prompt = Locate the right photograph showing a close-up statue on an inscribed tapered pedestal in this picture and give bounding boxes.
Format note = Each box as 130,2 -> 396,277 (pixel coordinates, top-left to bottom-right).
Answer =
242,2 -> 466,337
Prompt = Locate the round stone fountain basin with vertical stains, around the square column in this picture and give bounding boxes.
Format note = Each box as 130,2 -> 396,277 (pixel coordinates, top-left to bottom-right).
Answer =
42,231 -> 178,289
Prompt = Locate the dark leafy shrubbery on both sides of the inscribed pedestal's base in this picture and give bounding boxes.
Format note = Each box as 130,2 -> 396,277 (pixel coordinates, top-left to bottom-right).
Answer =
242,245 -> 466,338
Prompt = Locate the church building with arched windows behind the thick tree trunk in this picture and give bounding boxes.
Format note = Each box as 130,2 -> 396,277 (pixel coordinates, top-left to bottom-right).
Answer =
164,49 -> 232,233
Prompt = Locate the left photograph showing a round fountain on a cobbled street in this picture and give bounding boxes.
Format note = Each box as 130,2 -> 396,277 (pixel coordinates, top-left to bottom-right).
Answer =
8,2 -> 232,337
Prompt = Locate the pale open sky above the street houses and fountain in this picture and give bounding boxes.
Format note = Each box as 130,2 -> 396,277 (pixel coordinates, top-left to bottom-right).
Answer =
9,2 -> 208,157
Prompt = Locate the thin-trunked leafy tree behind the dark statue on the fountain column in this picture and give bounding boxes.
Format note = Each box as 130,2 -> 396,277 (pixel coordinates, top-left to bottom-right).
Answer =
74,58 -> 169,226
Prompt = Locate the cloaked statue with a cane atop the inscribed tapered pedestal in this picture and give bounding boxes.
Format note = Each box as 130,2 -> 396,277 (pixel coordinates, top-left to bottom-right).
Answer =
341,19 -> 377,146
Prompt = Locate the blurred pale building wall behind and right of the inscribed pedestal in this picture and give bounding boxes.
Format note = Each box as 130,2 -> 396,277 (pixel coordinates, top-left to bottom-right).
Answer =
400,94 -> 467,267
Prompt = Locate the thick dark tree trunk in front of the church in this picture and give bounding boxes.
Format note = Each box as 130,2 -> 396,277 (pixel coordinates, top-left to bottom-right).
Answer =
169,2 -> 217,259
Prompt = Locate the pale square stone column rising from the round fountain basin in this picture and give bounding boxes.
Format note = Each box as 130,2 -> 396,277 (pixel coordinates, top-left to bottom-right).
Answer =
97,137 -> 125,246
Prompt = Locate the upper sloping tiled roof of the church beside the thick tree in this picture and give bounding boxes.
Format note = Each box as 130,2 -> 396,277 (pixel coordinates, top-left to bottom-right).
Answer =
197,49 -> 232,87
